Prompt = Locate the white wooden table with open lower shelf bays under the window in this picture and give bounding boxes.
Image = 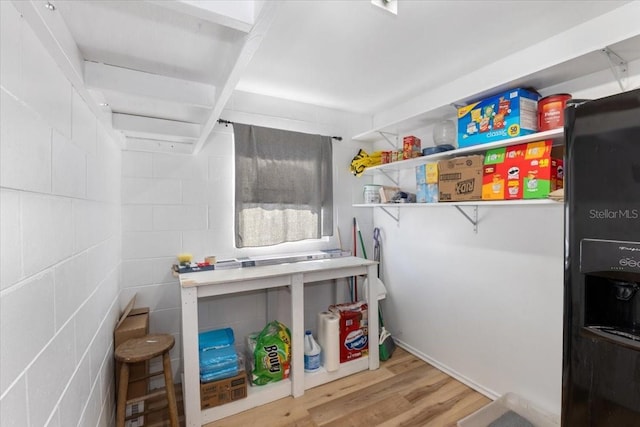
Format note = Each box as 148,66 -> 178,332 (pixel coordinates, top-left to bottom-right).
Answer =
180,257 -> 380,427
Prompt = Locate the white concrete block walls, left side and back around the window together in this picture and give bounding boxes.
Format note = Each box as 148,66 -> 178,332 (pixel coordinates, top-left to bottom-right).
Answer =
0,2 -> 371,427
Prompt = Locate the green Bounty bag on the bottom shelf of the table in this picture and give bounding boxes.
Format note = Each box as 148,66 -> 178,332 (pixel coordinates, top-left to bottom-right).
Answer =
252,320 -> 291,385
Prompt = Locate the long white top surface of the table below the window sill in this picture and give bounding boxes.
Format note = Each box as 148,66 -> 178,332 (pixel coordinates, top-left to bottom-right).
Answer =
180,256 -> 378,288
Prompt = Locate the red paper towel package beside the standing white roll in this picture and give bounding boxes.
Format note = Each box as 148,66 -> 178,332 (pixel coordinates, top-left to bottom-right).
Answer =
329,301 -> 369,363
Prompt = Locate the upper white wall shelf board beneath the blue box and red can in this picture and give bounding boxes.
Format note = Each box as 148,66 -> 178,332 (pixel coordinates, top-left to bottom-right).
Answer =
364,128 -> 564,175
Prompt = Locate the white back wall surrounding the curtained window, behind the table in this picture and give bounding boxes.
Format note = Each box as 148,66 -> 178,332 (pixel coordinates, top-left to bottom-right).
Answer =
121,93 -> 371,378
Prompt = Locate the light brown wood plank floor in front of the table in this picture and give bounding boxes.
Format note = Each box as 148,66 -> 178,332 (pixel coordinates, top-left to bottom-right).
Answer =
206,348 -> 491,427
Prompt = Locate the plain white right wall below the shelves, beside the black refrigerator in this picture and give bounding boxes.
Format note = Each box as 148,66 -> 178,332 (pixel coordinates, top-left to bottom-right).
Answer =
374,56 -> 640,415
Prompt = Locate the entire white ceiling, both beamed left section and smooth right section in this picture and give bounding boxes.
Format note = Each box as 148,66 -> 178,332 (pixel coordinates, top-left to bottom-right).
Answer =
23,0 -> 629,154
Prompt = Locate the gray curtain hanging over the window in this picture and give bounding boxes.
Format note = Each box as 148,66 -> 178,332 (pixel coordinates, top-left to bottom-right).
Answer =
233,124 -> 333,248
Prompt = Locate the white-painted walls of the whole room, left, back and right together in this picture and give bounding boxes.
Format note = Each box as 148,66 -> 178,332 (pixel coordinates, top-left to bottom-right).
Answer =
5,1 -> 640,427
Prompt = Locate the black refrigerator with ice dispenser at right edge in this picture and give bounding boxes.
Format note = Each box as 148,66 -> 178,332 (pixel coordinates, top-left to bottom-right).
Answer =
561,90 -> 640,427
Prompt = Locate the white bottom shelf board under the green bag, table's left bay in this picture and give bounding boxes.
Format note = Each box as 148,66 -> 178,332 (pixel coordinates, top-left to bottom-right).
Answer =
202,379 -> 291,424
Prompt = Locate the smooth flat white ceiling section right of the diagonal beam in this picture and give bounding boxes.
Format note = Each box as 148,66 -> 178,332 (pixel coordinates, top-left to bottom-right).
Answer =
237,0 -> 636,114
